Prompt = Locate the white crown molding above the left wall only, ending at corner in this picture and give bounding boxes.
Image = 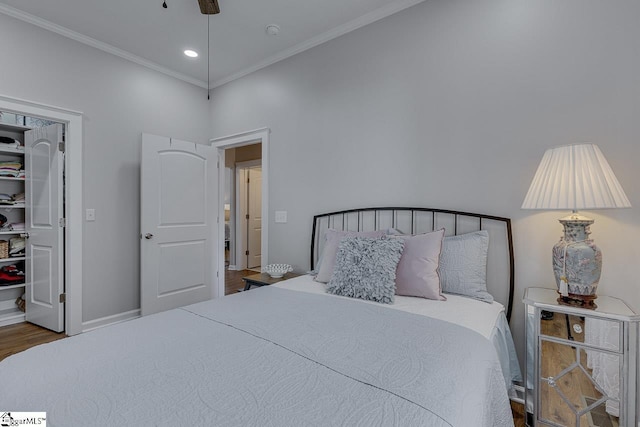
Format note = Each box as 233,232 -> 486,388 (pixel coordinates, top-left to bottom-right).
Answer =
0,3 -> 207,89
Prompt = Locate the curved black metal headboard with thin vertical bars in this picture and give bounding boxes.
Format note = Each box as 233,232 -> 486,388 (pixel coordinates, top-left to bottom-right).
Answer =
310,207 -> 515,320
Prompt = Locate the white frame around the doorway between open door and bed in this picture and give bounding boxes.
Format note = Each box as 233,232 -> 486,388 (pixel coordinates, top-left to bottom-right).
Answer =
209,127 -> 271,298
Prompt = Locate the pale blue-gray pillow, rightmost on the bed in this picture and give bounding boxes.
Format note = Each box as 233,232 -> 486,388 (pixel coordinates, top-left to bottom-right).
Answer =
440,230 -> 493,303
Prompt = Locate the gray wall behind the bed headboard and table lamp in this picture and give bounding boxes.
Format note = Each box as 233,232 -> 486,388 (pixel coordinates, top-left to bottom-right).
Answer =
211,0 -> 640,368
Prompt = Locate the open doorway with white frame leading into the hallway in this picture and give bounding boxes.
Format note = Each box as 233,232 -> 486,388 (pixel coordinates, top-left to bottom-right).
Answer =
211,128 -> 269,296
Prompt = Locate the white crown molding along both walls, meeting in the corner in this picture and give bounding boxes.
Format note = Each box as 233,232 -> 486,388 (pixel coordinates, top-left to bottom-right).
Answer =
0,0 -> 425,89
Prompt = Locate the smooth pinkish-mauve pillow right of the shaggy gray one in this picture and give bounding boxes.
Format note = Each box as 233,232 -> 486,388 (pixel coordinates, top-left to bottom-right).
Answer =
393,229 -> 446,301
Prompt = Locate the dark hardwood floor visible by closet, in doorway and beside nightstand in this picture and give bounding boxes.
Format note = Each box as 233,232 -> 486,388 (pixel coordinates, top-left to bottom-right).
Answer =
0,270 -> 525,427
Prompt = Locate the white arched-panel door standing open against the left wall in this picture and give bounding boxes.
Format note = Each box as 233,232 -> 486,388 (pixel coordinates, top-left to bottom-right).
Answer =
140,134 -> 217,316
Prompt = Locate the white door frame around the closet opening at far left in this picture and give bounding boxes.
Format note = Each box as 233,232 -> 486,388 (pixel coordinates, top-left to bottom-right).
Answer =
0,95 -> 83,335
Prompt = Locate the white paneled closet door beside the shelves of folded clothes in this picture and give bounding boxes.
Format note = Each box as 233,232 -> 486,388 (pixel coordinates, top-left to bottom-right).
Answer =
25,124 -> 64,332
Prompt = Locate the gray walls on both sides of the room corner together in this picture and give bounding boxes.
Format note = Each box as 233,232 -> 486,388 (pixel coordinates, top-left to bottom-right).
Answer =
0,0 -> 640,378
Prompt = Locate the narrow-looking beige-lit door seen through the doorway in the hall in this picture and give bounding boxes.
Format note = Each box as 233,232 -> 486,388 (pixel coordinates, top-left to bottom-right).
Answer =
247,166 -> 262,268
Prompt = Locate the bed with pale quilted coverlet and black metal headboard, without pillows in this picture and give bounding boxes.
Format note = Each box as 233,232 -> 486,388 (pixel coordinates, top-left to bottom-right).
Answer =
0,208 -> 520,427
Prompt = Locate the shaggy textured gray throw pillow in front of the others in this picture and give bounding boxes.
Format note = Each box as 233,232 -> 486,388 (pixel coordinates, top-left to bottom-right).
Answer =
327,237 -> 404,304
